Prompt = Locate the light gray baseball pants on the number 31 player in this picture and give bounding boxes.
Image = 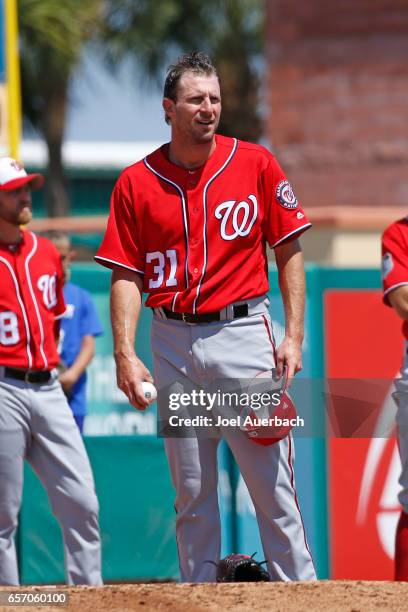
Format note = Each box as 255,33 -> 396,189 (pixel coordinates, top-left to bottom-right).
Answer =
152,299 -> 316,582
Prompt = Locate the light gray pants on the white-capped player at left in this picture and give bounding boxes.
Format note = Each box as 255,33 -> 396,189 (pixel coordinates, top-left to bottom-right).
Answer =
0,368 -> 102,585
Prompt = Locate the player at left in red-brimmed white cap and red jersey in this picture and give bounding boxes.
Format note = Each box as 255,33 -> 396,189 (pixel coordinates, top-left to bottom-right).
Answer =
0,157 -> 102,585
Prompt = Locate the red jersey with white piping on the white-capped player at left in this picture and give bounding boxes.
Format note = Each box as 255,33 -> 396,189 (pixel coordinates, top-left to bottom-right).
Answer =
0,231 -> 65,370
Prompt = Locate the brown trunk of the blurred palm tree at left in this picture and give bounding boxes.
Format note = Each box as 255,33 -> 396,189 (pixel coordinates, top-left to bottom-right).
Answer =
41,82 -> 70,217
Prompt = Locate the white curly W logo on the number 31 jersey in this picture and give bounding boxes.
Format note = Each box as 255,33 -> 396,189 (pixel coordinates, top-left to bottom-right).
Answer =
215,195 -> 258,240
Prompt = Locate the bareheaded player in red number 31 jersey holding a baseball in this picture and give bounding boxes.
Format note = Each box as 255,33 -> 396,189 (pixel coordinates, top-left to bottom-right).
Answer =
96,53 -> 316,582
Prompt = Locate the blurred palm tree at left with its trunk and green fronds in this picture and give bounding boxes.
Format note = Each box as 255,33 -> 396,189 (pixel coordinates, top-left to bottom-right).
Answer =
18,0 -> 101,216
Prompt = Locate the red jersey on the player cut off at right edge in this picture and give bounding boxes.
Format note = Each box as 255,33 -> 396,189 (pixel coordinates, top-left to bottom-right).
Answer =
382,217 -> 408,338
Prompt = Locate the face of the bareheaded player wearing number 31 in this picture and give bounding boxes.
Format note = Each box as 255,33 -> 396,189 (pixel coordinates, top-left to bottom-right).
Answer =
163,72 -> 221,144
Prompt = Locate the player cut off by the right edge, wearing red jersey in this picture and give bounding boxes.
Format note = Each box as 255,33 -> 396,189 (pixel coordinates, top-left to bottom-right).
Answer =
382,217 -> 408,581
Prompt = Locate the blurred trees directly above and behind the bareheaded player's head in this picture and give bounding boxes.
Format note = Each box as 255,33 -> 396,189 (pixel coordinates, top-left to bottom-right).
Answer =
101,0 -> 264,141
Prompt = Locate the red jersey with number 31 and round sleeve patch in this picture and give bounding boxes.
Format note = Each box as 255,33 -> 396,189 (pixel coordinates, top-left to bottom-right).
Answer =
96,135 -> 310,313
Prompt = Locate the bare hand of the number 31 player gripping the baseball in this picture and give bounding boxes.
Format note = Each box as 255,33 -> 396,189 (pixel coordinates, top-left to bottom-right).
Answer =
115,354 -> 153,410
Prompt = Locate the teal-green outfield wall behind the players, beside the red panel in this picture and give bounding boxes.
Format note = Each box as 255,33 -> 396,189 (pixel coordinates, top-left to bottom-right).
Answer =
17,264 -> 380,584
